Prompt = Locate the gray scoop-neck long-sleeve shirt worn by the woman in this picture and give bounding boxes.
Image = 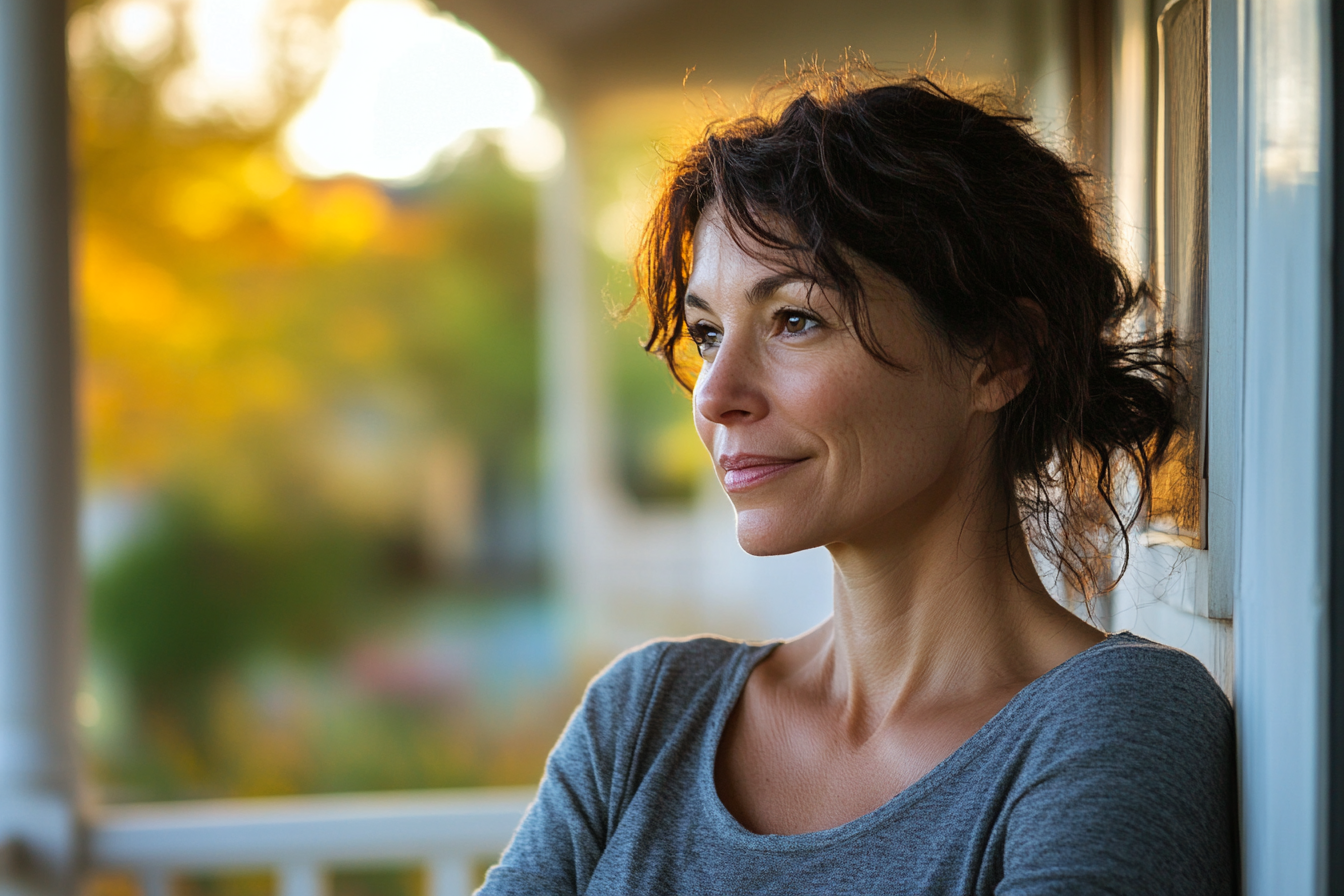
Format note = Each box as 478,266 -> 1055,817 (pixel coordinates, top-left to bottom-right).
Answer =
478,634 -> 1236,896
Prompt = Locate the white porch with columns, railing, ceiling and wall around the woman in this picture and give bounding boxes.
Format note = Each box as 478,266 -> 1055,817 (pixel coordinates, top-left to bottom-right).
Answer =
0,0 -> 1344,896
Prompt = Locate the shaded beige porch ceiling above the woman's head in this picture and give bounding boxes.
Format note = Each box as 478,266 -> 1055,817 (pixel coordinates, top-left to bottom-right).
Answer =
437,0 -> 1063,103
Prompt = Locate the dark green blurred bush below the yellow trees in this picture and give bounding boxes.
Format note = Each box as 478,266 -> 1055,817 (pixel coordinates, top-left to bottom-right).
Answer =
90,498 -> 373,709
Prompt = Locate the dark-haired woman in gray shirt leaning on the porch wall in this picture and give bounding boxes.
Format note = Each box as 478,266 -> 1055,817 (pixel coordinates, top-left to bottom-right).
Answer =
481,77 -> 1235,896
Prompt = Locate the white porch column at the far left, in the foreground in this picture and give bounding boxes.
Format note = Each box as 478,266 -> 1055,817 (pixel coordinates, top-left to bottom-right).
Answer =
0,0 -> 78,893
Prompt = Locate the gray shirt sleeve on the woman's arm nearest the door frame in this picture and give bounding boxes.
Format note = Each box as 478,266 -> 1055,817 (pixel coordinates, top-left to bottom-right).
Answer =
995,652 -> 1238,896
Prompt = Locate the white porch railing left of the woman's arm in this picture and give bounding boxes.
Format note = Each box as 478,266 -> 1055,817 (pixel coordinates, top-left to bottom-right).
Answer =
89,789 -> 534,896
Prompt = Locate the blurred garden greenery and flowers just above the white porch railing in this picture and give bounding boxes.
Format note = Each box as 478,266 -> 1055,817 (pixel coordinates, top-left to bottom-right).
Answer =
90,496 -> 582,801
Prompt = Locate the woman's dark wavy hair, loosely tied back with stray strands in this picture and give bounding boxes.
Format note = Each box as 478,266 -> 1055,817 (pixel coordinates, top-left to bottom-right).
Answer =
634,66 -> 1179,596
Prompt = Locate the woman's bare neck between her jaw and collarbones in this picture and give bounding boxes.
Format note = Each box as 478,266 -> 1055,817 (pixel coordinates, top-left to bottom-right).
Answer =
796,462 -> 1101,737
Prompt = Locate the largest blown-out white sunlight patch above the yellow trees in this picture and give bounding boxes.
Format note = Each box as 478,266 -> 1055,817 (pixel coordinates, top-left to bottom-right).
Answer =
284,0 -> 545,183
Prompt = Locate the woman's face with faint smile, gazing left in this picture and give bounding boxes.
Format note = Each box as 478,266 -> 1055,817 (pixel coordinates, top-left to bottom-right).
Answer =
685,212 -> 1001,555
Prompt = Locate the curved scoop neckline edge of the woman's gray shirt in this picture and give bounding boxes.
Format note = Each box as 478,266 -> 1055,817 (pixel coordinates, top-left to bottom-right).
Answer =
698,631 -> 1144,853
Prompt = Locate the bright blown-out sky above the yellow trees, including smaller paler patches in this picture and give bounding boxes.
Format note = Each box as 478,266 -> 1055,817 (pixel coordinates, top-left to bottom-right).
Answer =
70,0 -> 564,183
